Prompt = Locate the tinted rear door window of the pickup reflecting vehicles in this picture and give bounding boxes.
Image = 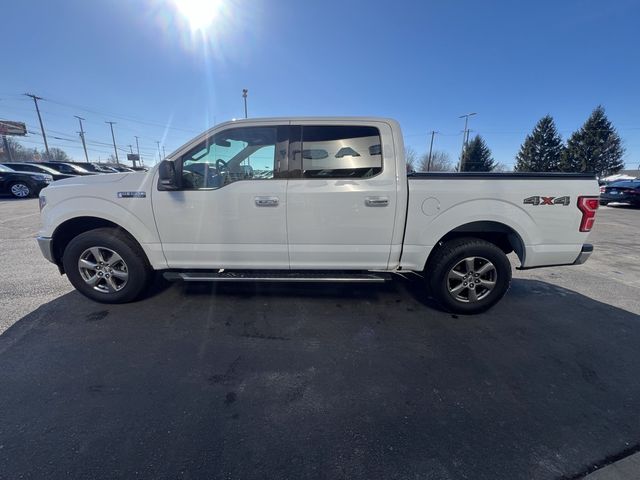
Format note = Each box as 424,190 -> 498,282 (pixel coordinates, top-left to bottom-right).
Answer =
294,125 -> 382,178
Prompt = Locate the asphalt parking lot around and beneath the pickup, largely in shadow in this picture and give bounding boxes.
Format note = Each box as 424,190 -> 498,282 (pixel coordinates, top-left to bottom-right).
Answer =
0,199 -> 640,480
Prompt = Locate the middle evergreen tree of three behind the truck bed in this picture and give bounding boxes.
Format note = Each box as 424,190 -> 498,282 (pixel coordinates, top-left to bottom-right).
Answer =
515,115 -> 564,172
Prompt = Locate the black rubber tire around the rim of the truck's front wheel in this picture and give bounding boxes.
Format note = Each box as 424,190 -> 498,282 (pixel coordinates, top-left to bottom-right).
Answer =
62,229 -> 150,303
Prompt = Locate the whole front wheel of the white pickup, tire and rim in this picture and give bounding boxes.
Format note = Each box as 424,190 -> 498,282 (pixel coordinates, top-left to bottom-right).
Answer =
62,228 -> 152,303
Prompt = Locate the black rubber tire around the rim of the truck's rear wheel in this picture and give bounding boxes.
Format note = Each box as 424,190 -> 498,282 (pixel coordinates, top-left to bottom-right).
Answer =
431,242 -> 511,314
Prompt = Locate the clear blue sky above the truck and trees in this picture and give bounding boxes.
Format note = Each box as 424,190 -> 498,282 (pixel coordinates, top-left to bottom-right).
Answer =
0,0 -> 640,167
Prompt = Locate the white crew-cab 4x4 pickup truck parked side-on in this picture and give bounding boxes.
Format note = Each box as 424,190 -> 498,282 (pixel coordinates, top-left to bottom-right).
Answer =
38,118 -> 599,313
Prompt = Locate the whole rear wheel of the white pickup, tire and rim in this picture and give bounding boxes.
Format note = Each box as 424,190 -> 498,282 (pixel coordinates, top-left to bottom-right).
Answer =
425,237 -> 511,314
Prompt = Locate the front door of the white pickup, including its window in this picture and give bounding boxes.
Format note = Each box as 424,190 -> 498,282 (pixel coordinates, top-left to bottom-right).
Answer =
153,125 -> 289,269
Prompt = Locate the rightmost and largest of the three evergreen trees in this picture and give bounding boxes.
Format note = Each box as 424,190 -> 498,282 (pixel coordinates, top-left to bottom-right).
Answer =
562,105 -> 624,177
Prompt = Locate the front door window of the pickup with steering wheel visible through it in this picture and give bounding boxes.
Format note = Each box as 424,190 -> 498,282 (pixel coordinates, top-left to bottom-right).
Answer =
182,127 -> 278,189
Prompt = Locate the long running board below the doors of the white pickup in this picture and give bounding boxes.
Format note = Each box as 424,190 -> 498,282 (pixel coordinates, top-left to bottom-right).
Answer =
163,270 -> 391,283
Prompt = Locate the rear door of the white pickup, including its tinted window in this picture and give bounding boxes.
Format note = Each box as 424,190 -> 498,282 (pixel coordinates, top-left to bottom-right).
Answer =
287,121 -> 397,269
